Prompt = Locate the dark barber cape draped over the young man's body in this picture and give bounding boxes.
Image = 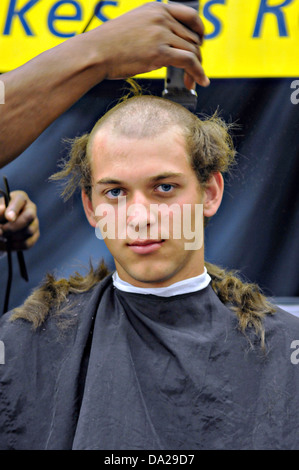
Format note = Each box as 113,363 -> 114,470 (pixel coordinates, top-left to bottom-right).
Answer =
0,275 -> 299,450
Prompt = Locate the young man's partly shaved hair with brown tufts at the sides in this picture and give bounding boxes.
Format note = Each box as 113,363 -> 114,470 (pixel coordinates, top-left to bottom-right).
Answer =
52,95 -> 235,199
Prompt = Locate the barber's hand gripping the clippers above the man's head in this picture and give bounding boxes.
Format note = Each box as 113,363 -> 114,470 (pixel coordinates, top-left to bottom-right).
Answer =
86,2 -> 210,88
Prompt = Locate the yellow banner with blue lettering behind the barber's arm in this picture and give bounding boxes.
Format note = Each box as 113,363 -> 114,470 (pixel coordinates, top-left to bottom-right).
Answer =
0,0 -> 299,78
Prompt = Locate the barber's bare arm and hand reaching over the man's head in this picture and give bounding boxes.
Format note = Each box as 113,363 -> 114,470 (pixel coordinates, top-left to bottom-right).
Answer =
0,3 -> 209,168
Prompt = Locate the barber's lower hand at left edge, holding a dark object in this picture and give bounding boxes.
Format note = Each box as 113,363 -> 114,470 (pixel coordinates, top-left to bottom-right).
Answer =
0,191 -> 40,251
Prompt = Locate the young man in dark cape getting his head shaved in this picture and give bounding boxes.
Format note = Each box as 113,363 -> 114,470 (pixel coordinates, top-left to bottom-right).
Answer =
0,96 -> 299,450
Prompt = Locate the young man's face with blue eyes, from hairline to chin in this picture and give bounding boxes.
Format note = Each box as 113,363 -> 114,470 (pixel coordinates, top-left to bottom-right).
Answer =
84,127 -> 204,287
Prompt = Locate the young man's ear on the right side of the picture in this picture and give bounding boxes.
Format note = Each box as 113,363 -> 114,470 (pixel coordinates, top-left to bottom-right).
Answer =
203,171 -> 224,217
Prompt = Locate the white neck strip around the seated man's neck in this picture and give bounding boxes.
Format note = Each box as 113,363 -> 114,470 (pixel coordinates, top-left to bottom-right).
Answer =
112,267 -> 211,297
